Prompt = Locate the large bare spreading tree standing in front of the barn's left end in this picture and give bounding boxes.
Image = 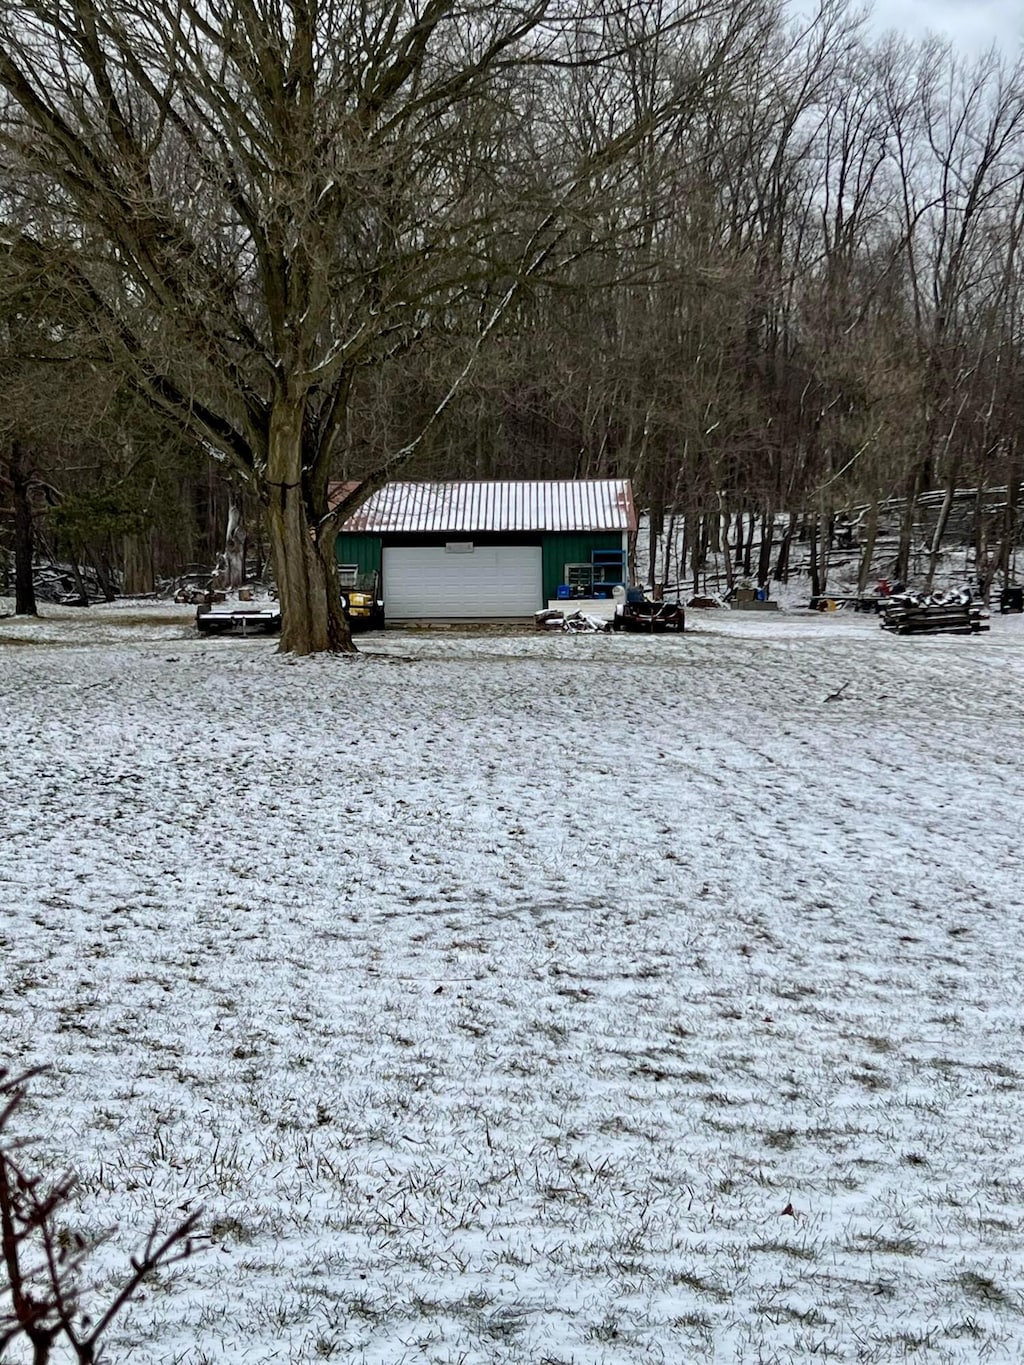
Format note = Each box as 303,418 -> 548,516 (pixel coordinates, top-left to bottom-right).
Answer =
0,0 -> 743,652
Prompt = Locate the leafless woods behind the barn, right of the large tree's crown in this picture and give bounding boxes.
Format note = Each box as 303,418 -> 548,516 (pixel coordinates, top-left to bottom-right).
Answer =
382,7 -> 1024,591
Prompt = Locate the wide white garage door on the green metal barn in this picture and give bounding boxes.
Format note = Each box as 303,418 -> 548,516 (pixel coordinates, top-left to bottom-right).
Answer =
384,542 -> 543,621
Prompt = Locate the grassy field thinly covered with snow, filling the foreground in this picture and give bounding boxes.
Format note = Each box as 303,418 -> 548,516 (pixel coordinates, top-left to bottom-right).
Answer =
0,606 -> 1024,1365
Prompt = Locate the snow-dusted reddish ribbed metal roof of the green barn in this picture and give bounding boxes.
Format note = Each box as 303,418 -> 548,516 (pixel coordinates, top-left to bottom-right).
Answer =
332,479 -> 636,535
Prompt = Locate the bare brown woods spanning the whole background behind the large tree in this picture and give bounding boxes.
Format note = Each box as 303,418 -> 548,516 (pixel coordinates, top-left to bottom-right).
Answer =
0,0 -> 1024,619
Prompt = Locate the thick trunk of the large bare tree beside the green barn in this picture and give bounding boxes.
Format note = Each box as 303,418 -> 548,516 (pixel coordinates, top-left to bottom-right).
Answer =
265,400 -> 355,654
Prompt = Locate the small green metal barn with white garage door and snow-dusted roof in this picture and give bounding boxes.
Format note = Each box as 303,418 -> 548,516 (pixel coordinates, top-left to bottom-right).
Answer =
337,479 -> 636,621
